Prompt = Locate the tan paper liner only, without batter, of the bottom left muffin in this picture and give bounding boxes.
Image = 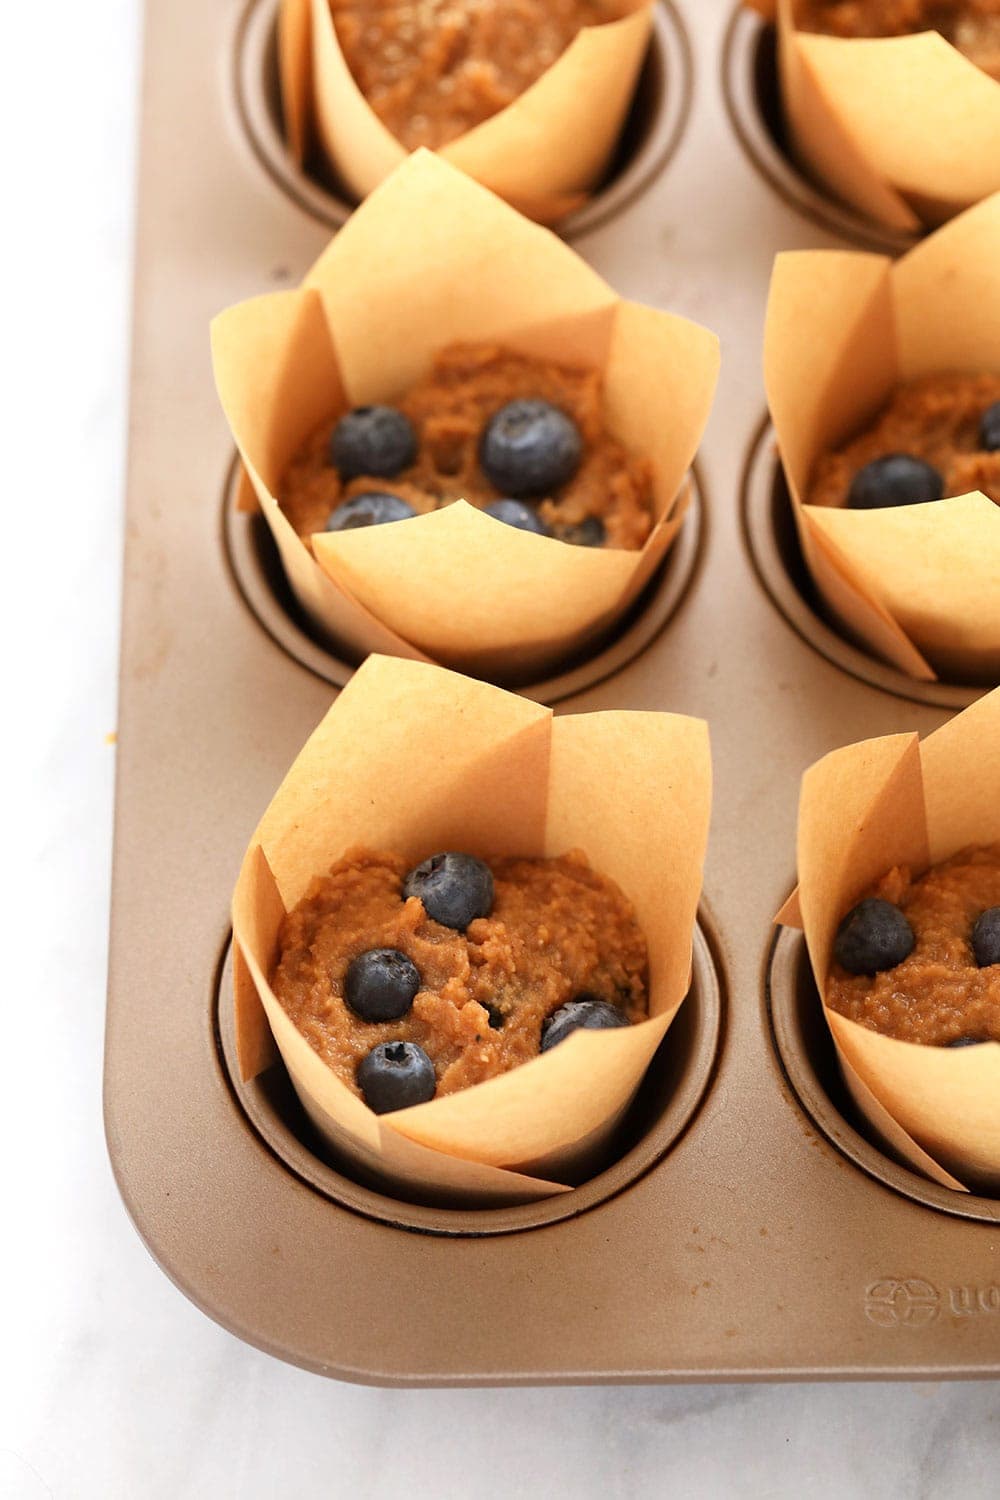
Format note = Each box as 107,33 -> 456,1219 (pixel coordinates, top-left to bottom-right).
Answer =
232,657 -> 711,1203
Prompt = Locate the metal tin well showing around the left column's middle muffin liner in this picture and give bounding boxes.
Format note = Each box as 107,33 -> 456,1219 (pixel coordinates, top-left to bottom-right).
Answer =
222,462 -> 706,704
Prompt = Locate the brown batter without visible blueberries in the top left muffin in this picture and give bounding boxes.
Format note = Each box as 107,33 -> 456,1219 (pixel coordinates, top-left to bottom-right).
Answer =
333,0 -> 618,152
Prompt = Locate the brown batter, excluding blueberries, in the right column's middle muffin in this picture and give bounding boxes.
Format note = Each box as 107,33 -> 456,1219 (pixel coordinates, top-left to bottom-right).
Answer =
807,374 -> 1000,506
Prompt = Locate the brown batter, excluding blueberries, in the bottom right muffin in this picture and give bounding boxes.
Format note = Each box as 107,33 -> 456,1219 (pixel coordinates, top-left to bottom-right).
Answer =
826,845 -> 1000,1047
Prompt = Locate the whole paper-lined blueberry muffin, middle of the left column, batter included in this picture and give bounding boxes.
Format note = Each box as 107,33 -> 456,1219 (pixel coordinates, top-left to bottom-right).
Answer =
213,152 -> 718,683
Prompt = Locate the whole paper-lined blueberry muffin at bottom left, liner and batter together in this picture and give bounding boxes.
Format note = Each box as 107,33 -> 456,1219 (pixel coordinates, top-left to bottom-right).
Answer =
232,657 -> 711,1205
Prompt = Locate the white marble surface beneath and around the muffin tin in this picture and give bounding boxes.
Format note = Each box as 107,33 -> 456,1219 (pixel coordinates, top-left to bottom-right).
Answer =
0,0 -> 1000,1500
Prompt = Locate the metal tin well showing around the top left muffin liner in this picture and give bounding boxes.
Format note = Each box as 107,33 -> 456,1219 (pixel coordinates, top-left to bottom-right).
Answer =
232,0 -> 693,239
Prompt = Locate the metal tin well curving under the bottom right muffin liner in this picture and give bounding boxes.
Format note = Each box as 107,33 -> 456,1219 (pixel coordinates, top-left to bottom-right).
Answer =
766,927 -> 1000,1224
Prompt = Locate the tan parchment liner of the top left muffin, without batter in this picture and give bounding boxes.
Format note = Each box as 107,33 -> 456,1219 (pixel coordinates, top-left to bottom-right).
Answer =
279,0 -> 652,224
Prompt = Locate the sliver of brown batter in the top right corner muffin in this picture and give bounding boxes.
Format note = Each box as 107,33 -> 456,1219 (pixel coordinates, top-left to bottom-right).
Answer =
796,0 -> 1000,78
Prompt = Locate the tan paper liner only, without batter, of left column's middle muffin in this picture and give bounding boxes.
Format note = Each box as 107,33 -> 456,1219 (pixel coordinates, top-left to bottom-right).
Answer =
211,152 -> 718,681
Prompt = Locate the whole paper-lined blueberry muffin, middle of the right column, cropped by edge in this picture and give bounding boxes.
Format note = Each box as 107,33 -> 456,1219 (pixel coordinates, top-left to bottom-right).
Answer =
765,195 -> 1000,684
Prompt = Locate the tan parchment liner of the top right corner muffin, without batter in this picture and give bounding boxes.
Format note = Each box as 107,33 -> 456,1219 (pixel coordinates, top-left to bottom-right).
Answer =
748,0 -> 1000,231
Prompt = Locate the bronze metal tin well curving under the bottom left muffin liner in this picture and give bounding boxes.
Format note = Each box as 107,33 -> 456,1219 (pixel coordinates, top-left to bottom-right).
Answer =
214,926 -> 723,1235
